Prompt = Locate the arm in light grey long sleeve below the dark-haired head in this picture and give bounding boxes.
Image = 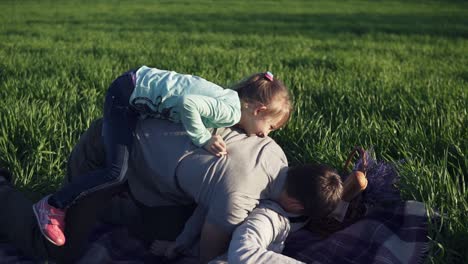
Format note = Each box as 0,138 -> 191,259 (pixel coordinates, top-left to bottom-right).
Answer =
228,208 -> 303,264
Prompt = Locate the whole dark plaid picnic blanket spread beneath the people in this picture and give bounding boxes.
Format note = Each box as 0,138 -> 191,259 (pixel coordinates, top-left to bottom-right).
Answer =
0,201 -> 428,264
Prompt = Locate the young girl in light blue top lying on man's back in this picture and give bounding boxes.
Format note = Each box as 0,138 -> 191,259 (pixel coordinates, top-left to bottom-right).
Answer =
33,66 -> 291,246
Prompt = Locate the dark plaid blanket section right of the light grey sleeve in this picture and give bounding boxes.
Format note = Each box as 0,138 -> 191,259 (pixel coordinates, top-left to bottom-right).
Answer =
283,201 -> 428,263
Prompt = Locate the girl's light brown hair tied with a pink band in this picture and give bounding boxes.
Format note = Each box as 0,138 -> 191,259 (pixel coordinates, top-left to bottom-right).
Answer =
232,72 -> 292,126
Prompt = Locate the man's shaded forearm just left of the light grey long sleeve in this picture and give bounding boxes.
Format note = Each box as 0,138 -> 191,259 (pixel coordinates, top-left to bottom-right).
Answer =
200,221 -> 231,263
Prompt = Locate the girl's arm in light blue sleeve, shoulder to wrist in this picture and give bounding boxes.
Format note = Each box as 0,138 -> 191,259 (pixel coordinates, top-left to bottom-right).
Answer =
180,94 -> 240,147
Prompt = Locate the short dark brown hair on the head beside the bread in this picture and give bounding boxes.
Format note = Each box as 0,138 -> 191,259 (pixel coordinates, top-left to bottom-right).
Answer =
286,164 -> 343,218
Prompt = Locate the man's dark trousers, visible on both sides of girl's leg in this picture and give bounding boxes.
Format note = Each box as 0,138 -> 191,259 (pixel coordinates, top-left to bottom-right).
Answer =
0,120 -> 193,263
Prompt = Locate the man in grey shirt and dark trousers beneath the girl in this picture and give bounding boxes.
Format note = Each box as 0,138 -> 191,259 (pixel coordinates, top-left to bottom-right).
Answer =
0,119 -> 341,262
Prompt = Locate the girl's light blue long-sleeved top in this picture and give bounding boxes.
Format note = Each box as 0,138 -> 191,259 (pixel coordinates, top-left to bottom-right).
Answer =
130,66 -> 241,146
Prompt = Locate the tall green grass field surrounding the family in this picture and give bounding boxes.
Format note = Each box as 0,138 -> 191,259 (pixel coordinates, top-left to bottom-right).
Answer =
0,0 -> 468,263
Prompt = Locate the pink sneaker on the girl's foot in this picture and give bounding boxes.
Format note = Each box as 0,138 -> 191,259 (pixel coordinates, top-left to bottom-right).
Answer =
33,195 -> 65,246
